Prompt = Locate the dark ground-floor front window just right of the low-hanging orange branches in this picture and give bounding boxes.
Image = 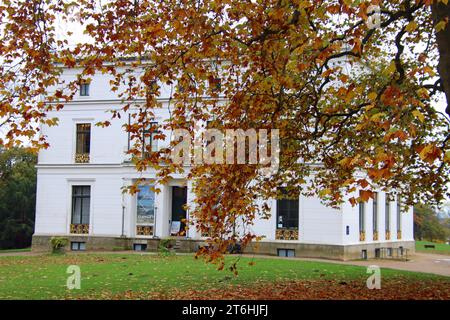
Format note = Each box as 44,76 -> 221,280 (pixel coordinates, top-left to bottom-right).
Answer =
276,188 -> 299,240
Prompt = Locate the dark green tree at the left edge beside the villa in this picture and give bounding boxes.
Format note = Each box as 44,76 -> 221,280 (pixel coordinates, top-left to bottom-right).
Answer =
0,148 -> 37,249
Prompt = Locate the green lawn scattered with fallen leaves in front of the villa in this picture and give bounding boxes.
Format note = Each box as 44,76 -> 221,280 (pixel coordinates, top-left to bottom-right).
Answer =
0,253 -> 449,299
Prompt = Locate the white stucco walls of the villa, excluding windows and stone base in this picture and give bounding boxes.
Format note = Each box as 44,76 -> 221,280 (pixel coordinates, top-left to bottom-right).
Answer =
35,70 -> 413,245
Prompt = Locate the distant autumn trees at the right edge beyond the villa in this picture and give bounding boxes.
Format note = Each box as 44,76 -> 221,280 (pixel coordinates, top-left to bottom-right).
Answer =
414,205 -> 450,241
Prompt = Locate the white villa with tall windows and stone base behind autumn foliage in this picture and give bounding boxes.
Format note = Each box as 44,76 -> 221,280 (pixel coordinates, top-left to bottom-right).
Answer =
33,69 -> 414,260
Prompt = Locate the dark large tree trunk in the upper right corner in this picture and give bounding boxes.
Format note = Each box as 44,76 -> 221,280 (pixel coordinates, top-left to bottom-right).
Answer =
432,0 -> 450,116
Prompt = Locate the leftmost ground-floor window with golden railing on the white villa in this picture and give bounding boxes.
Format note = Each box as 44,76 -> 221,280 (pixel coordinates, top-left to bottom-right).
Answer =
70,186 -> 91,234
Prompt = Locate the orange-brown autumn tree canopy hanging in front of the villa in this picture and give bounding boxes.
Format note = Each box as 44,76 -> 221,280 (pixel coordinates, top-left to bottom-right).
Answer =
0,0 -> 450,259
